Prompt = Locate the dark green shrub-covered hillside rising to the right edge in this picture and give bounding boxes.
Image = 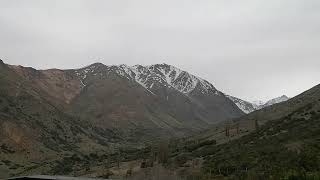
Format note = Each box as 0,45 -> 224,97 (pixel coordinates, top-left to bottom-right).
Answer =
204,85 -> 320,179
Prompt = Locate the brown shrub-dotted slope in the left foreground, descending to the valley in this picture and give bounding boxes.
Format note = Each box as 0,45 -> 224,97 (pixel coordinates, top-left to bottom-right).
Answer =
0,60 -> 112,178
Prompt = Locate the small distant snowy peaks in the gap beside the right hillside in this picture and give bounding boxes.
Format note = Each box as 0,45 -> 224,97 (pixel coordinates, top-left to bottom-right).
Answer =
227,95 -> 290,114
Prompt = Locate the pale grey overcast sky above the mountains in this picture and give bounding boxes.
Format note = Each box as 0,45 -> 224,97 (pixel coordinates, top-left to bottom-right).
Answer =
0,0 -> 320,100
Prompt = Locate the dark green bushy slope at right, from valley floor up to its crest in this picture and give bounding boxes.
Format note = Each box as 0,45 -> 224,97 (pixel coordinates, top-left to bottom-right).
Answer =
165,85 -> 320,179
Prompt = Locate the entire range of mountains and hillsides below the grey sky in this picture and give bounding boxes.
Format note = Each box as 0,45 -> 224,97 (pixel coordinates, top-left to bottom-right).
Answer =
0,61 -> 320,178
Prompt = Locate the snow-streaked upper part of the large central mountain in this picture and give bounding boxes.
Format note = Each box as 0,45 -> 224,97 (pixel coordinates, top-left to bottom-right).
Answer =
76,63 -> 221,95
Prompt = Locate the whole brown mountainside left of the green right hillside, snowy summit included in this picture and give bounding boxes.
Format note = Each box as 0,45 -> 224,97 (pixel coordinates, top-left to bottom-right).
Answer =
0,61 -> 243,176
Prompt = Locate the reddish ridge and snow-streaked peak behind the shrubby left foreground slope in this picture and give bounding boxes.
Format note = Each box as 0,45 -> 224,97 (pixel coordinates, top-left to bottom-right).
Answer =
0,59 -> 243,148
